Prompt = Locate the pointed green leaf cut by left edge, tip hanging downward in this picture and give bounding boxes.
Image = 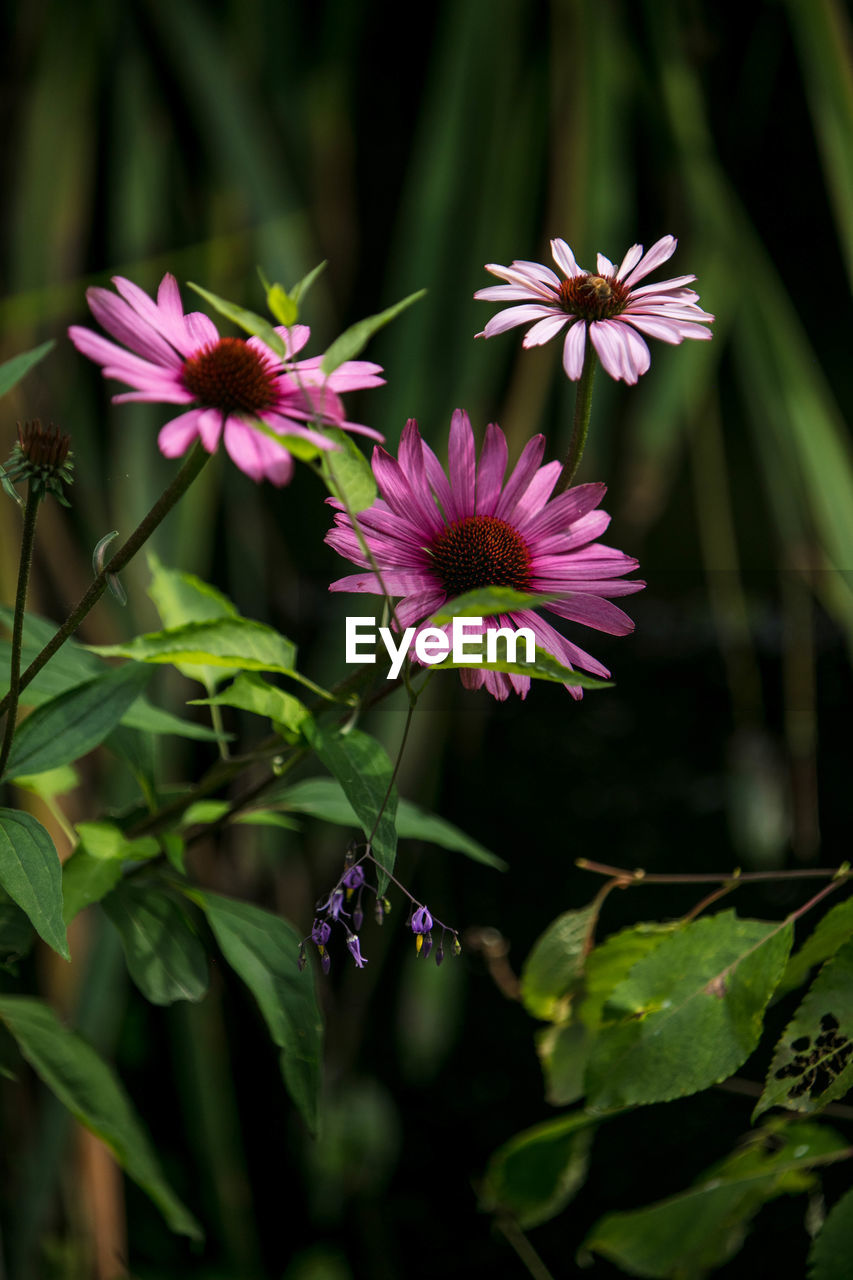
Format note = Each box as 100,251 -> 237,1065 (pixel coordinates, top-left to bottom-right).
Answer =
0,809 -> 70,960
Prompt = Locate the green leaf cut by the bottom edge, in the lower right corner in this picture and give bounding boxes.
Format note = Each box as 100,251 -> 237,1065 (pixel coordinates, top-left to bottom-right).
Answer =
581,1124 -> 844,1280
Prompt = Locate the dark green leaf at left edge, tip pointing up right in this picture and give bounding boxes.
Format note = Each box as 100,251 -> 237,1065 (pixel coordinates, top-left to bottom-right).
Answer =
4,663 -> 150,778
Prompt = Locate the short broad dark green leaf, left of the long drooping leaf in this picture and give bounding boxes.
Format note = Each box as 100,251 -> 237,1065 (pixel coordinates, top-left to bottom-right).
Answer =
101,881 -> 207,1005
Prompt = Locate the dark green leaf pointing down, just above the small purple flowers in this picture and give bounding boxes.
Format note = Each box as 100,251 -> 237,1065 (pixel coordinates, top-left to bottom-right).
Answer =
304,721 -> 397,896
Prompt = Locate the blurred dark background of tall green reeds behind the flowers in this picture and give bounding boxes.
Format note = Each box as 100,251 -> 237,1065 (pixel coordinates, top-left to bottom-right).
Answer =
0,0 -> 853,1280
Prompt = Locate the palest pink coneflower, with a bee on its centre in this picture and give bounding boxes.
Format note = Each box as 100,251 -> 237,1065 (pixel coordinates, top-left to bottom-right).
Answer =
474,236 -> 713,383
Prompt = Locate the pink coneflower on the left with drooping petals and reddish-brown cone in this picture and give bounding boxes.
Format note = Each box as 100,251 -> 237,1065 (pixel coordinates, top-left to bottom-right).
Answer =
68,275 -> 384,486
